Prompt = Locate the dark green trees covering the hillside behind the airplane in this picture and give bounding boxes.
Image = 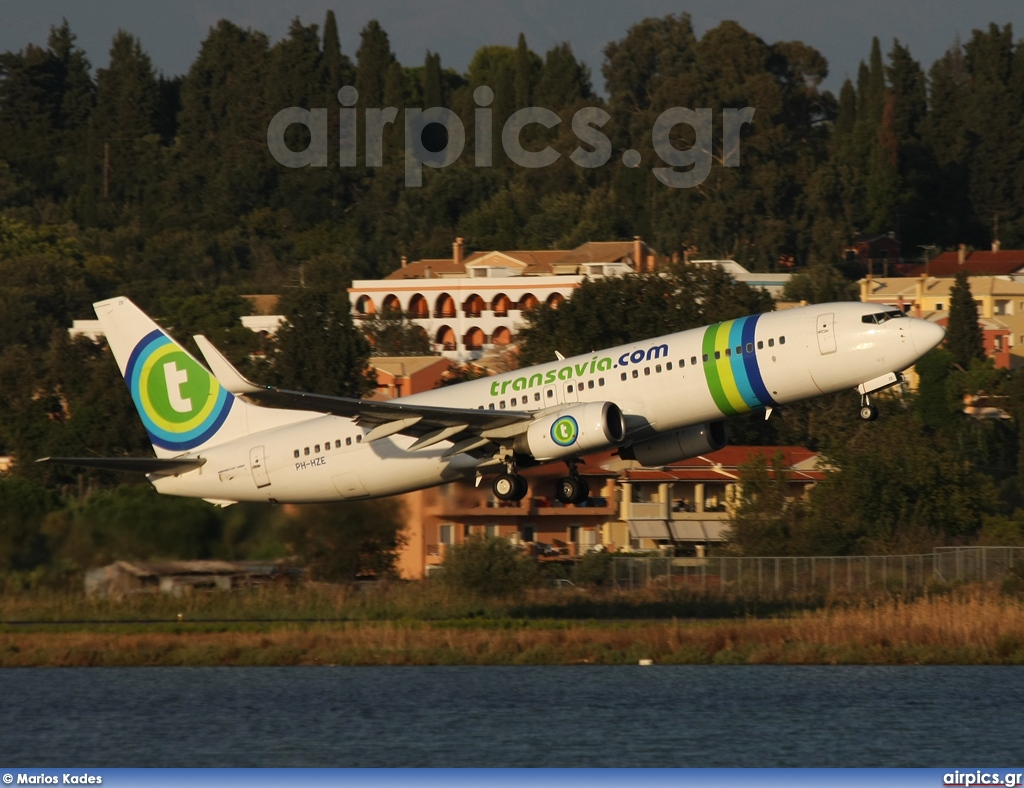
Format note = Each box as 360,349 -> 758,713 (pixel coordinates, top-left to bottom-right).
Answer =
0,12 -> 1024,571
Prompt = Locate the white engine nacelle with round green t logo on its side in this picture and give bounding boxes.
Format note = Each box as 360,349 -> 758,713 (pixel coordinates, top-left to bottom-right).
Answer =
513,402 -> 626,462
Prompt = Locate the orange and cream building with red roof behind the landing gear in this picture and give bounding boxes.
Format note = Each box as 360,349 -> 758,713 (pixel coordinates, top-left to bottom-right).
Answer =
398,446 -> 824,579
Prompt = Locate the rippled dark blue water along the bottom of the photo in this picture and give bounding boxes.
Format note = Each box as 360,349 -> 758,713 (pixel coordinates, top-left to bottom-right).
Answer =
0,665 -> 1024,768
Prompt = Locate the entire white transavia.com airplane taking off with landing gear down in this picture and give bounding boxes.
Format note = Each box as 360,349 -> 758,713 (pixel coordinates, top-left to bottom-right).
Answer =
40,298 -> 944,506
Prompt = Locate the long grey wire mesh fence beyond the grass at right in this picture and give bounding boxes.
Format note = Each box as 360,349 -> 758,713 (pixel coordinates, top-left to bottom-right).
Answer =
611,548 -> 1024,598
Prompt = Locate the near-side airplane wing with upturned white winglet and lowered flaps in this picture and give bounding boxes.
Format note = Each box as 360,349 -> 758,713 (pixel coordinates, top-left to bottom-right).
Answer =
194,336 -> 535,451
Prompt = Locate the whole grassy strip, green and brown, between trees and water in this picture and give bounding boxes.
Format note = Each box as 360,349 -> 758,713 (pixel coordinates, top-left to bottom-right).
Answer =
6,584 -> 1024,667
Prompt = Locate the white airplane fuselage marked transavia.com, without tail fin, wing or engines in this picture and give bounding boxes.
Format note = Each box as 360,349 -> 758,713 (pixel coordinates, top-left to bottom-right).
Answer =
151,303 -> 941,502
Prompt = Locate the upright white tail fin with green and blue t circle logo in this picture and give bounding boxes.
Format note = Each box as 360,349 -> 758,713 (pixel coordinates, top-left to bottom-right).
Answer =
93,297 -> 249,456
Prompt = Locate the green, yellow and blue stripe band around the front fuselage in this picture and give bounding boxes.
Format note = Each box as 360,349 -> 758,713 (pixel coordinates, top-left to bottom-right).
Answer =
701,315 -> 776,415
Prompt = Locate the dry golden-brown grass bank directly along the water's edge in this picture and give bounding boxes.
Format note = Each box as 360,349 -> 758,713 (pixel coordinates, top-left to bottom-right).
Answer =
0,588 -> 1024,667
